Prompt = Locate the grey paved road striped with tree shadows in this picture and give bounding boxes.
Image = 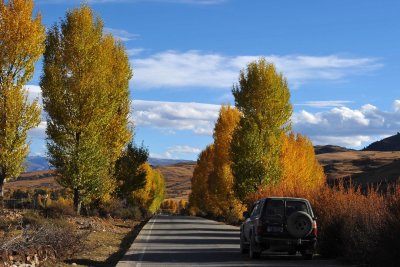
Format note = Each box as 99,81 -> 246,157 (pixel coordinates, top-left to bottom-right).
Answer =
117,215 -> 343,267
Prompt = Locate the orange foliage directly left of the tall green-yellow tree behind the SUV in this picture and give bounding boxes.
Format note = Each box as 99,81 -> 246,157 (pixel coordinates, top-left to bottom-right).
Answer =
189,106 -> 244,222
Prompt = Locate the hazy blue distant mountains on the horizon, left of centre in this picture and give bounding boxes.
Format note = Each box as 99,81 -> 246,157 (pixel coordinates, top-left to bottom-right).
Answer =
25,156 -> 196,172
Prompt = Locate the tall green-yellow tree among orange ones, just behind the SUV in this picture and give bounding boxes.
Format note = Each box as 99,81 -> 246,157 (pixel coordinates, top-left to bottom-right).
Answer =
231,58 -> 292,199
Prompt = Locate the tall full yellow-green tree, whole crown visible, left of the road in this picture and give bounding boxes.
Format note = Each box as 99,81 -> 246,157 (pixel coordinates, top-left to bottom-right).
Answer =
40,5 -> 132,214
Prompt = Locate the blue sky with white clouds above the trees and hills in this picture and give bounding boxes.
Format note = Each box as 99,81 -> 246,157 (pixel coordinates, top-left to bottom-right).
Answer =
27,0 -> 400,160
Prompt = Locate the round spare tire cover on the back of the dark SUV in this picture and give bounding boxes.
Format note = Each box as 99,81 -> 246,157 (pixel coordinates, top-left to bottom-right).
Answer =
287,211 -> 313,238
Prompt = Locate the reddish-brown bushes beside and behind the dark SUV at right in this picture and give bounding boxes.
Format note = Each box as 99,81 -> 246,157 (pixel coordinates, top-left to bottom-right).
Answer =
249,182 -> 400,266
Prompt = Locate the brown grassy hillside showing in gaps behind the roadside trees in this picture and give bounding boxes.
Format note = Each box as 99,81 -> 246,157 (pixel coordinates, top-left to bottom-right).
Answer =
5,151 -> 400,200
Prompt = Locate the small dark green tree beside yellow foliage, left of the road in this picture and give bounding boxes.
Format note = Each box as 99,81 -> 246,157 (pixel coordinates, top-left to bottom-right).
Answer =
115,143 -> 149,201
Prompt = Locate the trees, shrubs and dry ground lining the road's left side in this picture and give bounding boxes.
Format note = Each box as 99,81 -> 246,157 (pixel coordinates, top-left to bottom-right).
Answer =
0,0 -> 165,266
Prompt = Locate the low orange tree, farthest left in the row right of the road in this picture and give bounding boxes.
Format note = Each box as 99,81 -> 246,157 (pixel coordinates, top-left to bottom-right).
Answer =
189,145 -> 214,214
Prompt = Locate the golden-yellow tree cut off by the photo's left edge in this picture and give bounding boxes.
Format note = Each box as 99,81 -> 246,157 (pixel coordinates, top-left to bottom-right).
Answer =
0,0 -> 45,197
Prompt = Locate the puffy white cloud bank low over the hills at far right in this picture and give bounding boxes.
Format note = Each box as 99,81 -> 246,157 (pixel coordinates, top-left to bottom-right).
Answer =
292,100 -> 400,148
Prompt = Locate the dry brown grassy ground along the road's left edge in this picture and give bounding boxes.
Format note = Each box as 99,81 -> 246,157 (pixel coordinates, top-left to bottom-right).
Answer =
0,210 -> 144,266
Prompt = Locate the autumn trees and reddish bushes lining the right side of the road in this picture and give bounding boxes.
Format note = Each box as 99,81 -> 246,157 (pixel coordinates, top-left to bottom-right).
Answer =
188,58 -> 400,266
